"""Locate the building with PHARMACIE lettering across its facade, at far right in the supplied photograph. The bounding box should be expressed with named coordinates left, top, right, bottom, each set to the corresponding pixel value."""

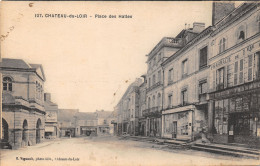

left=209, top=3, right=260, bottom=146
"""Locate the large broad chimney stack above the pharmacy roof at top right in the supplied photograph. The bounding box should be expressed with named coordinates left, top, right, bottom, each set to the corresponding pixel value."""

left=212, top=2, right=235, bottom=25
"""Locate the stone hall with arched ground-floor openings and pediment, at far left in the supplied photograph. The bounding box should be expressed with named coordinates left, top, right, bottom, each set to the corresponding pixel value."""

left=0, top=58, right=45, bottom=149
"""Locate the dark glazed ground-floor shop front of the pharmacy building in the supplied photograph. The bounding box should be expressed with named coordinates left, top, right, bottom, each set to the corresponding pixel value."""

left=210, top=80, right=260, bottom=145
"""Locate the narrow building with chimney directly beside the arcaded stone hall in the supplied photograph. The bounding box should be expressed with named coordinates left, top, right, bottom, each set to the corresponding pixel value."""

left=44, top=93, right=59, bottom=139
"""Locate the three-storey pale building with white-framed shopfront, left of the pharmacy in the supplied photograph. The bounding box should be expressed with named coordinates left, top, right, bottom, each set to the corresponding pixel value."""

left=162, top=23, right=212, bottom=140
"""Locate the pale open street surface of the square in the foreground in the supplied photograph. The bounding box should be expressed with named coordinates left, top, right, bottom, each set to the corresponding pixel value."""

left=1, top=136, right=259, bottom=166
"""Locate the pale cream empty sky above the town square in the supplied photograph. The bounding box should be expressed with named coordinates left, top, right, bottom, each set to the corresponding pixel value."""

left=1, top=1, right=220, bottom=112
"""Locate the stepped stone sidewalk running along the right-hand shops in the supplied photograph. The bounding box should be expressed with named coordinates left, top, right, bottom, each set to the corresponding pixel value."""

left=123, top=136, right=260, bottom=160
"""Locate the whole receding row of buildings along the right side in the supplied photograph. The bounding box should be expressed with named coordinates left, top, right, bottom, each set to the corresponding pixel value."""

left=115, top=2, right=260, bottom=147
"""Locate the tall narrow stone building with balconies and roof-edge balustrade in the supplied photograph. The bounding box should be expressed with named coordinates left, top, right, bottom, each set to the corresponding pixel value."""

left=142, top=37, right=184, bottom=137
